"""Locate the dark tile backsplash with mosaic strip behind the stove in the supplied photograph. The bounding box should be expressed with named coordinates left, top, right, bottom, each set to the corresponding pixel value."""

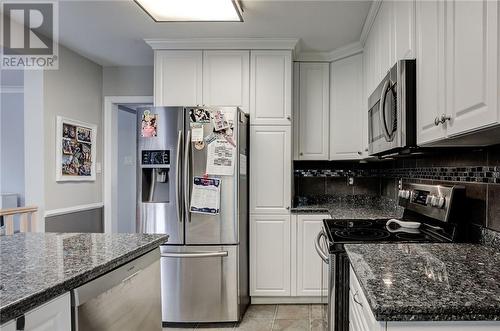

left=294, top=144, right=500, bottom=231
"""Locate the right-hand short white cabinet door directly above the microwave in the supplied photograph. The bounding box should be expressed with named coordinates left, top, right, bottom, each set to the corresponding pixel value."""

left=392, top=1, right=415, bottom=64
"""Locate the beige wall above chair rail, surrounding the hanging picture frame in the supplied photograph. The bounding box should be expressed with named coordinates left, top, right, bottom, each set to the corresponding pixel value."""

left=43, top=45, right=103, bottom=211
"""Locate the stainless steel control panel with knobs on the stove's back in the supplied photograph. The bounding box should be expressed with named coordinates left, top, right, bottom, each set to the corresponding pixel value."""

left=398, top=184, right=465, bottom=222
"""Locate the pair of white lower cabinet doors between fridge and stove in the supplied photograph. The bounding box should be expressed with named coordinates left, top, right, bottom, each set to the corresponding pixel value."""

left=250, top=214, right=330, bottom=303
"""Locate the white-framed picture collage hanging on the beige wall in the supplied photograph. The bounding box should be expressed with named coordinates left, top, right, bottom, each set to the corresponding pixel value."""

left=56, top=116, right=97, bottom=182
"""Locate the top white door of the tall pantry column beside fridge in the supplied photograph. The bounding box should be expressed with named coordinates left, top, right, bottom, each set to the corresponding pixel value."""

left=250, top=51, right=292, bottom=125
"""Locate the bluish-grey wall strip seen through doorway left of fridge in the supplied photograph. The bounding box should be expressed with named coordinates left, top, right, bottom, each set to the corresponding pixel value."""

left=116, top=106, right=137, bottom=233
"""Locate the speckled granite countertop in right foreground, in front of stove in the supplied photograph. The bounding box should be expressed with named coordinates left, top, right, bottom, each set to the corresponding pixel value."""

left=344, top=243, right=500, bottom=321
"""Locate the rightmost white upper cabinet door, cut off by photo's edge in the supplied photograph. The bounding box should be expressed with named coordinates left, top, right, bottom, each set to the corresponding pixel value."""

left=446, top=0, right=499, bottom=135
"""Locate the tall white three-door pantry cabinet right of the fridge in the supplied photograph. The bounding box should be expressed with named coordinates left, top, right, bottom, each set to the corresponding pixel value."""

left=250, top=50, right=292, bottom=296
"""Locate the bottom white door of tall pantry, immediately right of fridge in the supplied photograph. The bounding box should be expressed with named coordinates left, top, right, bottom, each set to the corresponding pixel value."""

left=250, top=215, right=291, bottom=296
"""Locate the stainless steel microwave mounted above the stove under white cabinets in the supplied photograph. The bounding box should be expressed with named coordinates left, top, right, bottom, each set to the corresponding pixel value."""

left=368, top=60, right=417, bottom=156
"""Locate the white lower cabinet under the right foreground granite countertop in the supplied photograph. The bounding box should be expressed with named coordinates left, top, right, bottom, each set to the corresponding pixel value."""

left=349, top=267, right=500, bottom=331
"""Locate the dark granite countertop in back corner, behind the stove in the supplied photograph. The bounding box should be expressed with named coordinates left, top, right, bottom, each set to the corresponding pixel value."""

left=291, top=195, right=403, bottom=219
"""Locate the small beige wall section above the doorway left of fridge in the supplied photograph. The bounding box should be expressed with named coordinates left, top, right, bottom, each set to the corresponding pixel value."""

left=103, top=66, right=153, bottom=96
